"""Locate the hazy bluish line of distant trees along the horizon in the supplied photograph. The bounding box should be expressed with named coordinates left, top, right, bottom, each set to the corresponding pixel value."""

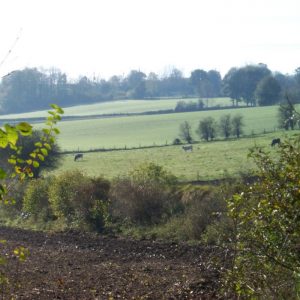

left=0, top=64, right=300, bottom=113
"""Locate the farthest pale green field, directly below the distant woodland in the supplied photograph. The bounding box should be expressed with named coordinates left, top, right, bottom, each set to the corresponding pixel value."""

left=0, top=98, right=232, bottom=120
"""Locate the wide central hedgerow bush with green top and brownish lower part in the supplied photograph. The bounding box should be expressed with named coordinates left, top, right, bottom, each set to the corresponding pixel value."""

left=110, top=163, right=181, bottom=225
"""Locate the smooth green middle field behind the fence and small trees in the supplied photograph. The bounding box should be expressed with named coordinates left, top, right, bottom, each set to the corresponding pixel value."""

left=37, top=106, right=278, bottom=151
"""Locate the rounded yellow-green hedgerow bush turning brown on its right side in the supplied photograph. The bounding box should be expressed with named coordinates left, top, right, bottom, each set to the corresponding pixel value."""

left=49, top=171, right=110, bottom=231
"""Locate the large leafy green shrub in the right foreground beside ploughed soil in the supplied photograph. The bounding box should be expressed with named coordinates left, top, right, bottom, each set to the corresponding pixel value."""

left=227, top=137, right=300, bottom=299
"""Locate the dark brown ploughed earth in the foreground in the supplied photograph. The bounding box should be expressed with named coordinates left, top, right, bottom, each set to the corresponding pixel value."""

left=0, top=227, right=223, bottom=299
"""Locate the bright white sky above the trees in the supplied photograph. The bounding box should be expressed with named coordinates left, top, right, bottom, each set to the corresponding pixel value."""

left=0, top=0, right=300, bottom=79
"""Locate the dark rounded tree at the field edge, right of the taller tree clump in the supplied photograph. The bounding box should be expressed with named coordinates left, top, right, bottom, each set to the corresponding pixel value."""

left=255, top=76, right=281, bottom=106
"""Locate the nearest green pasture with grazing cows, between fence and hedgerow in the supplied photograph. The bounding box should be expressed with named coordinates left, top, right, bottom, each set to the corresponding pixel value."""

left=49, top=132, right=299, bottom=181
